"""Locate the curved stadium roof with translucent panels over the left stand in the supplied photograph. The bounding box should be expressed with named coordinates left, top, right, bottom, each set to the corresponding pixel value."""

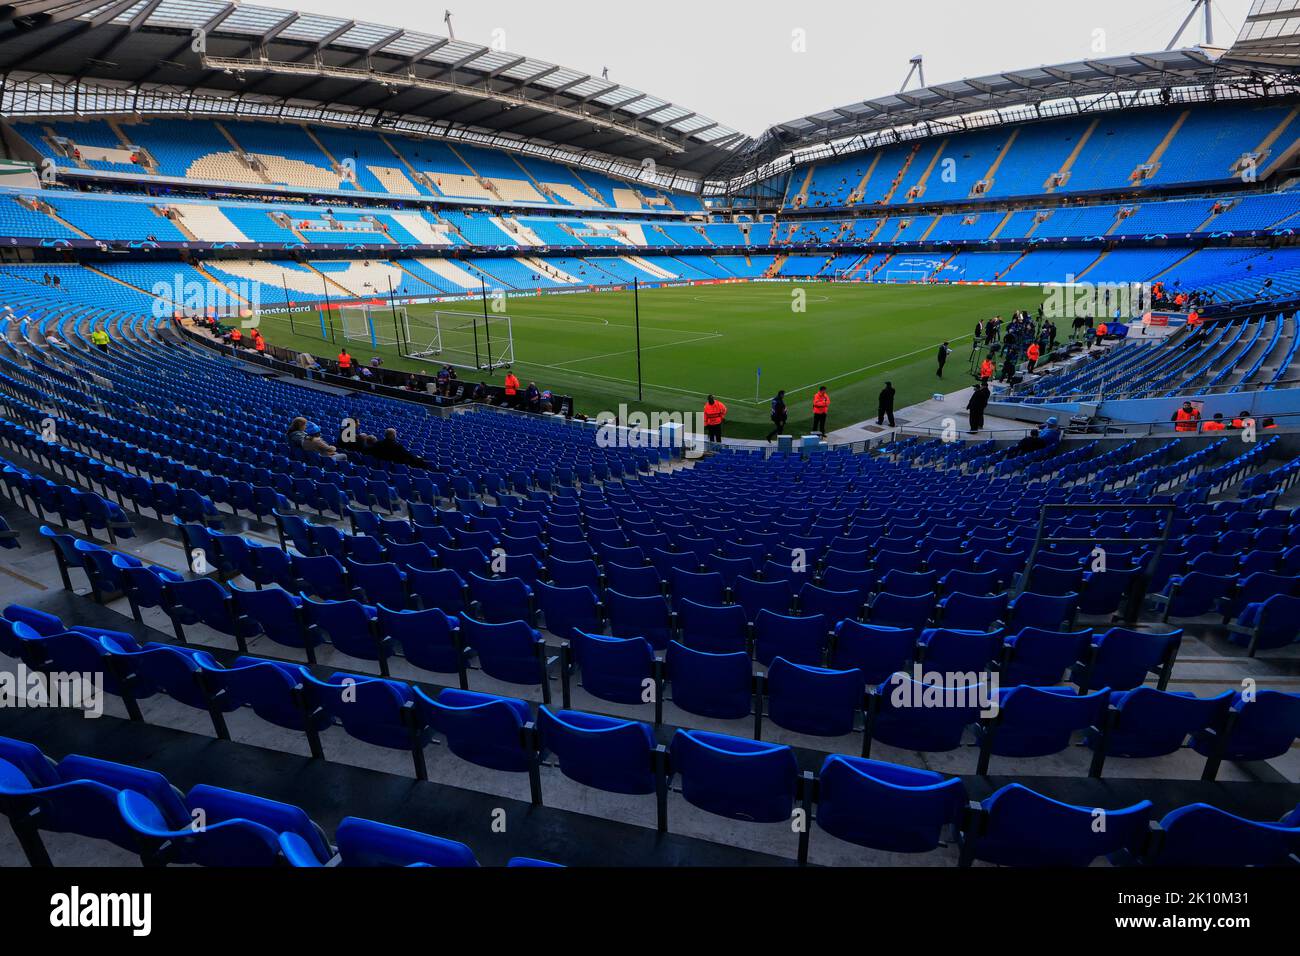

left=0, top=0, right=751, bottom=176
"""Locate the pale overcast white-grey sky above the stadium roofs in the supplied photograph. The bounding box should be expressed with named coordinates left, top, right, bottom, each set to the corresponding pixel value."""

left=287, top=0, right=1251, bottom=134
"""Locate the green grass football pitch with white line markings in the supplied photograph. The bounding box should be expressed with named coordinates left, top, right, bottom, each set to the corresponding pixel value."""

left=250, top=282, right=1045, bottom=438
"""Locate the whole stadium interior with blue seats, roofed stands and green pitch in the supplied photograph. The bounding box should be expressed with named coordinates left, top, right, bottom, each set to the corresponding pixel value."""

left=0, top=0, right=1300, bottom=920
